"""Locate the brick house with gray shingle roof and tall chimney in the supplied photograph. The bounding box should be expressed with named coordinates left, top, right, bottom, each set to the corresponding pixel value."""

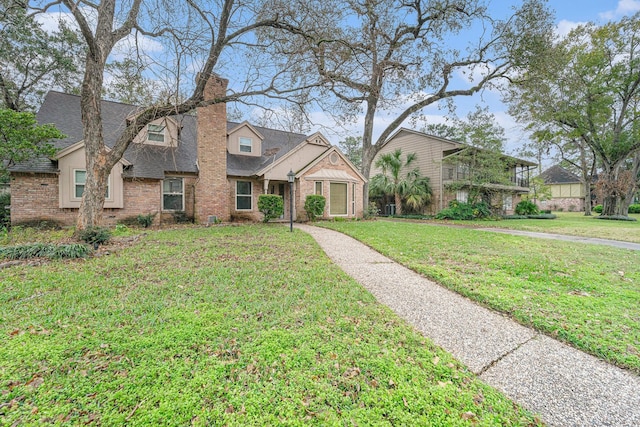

left=10, top=76, right=366, bottom=225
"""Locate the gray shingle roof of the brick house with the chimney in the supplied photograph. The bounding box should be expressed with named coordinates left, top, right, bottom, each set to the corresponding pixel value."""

left=11, top=91, right=307, bottom=179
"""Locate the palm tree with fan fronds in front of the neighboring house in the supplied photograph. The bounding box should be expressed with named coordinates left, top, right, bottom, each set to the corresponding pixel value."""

left=369, top=148, right=431, bottom=215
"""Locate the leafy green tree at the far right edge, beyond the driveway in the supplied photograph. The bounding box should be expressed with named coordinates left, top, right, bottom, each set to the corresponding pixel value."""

left=510, top=15, right=640, bottom=216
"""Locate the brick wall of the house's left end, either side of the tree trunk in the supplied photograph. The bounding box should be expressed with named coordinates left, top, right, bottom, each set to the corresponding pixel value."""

left=11, top=173, right=162, bottom=226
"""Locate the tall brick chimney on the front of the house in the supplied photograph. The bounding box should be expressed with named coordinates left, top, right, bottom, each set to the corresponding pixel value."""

left=195, top=74, right=230, bottom=223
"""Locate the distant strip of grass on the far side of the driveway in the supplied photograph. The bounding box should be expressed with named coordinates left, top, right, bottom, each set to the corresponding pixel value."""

left=424, top=212, right=640, bottom=243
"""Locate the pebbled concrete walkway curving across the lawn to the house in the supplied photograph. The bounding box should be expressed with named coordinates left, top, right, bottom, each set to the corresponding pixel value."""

left=296, top=224, right=640, bottom=427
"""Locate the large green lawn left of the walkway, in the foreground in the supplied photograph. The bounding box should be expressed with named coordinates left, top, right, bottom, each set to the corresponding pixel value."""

left=0, top=225, right=538, bottom=426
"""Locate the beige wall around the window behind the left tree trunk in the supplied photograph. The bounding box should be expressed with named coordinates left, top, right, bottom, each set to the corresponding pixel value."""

left=58, top=148, right=124, bottom=208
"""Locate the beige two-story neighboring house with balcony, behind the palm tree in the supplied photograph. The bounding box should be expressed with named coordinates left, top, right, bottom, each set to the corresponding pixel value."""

left=371, top=128, right=536, bottom=214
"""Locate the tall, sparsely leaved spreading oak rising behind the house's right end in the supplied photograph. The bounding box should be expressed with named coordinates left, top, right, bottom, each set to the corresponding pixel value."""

left=267, top=0, right=551, bottom=207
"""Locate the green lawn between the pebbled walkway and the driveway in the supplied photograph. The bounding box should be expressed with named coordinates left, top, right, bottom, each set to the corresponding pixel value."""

left=322, top=221, right=640, bottom=373
